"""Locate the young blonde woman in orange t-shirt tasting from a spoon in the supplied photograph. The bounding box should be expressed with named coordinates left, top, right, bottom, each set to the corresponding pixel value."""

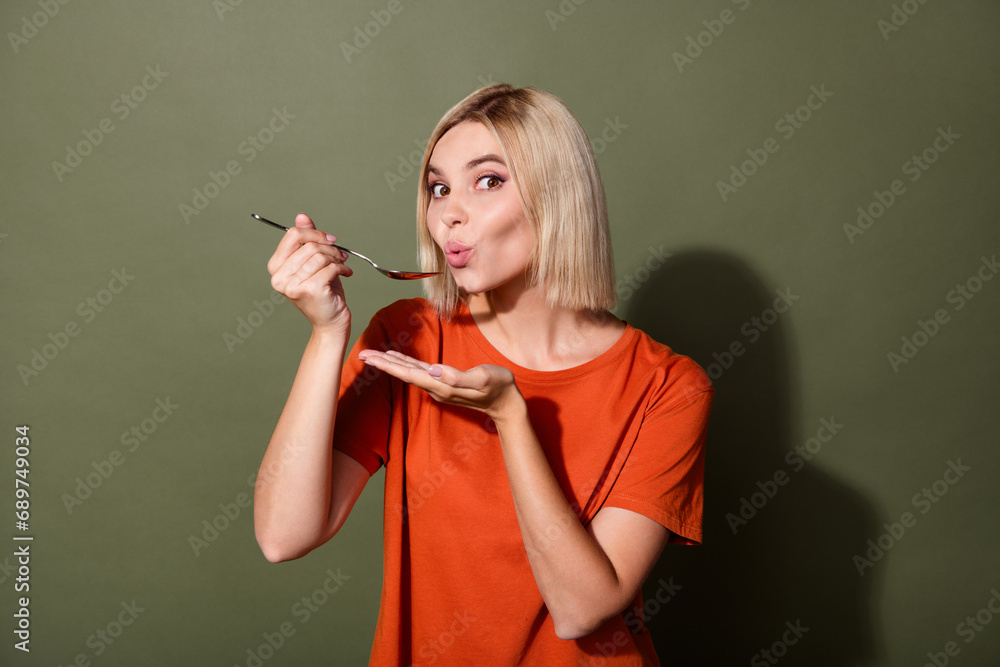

left=254, top=84, right=712, bottom=666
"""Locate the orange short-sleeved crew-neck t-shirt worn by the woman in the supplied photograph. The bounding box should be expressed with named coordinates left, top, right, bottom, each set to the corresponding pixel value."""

left=333, top=299, right=712, bottom=667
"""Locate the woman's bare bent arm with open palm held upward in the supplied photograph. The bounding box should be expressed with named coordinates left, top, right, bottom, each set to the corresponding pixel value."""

left=361, top=350, right=670, bottom=639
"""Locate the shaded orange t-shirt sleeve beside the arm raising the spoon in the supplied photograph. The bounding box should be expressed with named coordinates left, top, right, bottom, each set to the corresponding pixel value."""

left=333, top=304, right=408, bottom=475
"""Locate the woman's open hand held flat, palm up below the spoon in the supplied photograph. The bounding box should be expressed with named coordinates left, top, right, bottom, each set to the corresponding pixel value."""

left=358, top=350, right=524, bottom=420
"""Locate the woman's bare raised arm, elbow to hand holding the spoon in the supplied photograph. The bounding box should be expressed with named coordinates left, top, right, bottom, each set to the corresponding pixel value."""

left=254, top=214, right=369, bottom=562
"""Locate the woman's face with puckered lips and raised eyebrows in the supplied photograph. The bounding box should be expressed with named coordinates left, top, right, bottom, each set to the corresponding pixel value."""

left=426, top=121, right=535, bottom=294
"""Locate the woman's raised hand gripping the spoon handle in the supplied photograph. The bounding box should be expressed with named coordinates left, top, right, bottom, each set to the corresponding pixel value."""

left=267, top=213, right=354, bottom=335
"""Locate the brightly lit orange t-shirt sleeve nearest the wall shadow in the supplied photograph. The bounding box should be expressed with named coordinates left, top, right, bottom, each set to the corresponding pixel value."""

left=604, top=362, right=713, bottom=544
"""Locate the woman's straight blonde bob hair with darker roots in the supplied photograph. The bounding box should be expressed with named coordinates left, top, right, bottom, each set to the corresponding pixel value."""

left=417, top=84, right=615, bottom=317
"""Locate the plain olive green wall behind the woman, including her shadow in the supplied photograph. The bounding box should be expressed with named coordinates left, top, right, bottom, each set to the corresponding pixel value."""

left=0, top=0, right=1000, bottom=667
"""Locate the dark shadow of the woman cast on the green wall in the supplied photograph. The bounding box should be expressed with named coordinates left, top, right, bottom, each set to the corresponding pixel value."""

left=622, top=252, right=881, bottom=665
